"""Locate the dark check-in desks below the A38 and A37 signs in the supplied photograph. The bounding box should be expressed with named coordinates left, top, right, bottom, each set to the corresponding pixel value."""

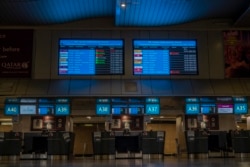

left=93, top=131, right=165, bottom=159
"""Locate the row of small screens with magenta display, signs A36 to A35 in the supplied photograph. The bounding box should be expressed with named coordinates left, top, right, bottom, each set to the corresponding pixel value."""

left=185, top=103, right=248, bottom=115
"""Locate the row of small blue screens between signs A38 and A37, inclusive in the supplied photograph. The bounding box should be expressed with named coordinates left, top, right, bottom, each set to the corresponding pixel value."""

left=96, top=104, right=160, bottom=116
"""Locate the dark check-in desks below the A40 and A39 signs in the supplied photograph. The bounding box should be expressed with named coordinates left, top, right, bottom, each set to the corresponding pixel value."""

left=0, top=132, right=74, bottom=159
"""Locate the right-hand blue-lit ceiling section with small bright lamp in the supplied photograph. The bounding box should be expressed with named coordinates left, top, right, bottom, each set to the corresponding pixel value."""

left=115, top=0, right=249, bottom=26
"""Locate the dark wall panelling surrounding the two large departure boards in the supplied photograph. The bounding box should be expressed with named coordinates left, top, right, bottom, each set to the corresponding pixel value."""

left=33, top=29, right=224, bottom=79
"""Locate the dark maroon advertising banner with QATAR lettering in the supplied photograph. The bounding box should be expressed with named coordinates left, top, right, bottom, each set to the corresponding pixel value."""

left=0, top=29, right=33, bottom=78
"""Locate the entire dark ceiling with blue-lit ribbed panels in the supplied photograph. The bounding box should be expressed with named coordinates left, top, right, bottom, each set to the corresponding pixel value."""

left=0, top=0, right=250, bottom=28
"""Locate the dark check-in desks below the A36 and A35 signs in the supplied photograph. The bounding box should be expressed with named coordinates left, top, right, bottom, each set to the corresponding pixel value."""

left=185, top=130, right=250, bottom=157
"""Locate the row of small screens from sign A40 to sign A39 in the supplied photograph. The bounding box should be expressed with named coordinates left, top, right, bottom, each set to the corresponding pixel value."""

left=4, top=104, right=70, bottom=116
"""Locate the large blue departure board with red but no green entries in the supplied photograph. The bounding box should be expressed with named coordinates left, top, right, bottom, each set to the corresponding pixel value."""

left=133, top=40, right=198, bottom=75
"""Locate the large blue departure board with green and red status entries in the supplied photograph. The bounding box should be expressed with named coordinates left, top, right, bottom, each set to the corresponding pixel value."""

left=58, top=39, right=124, bottom=75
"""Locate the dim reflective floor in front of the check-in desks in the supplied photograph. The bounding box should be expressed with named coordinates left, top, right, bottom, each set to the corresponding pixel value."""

left=0, top=156, right=250, bottom=167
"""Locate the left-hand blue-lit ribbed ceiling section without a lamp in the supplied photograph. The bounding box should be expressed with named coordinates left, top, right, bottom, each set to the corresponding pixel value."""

left=0, top=0, right=115, bottom=25
